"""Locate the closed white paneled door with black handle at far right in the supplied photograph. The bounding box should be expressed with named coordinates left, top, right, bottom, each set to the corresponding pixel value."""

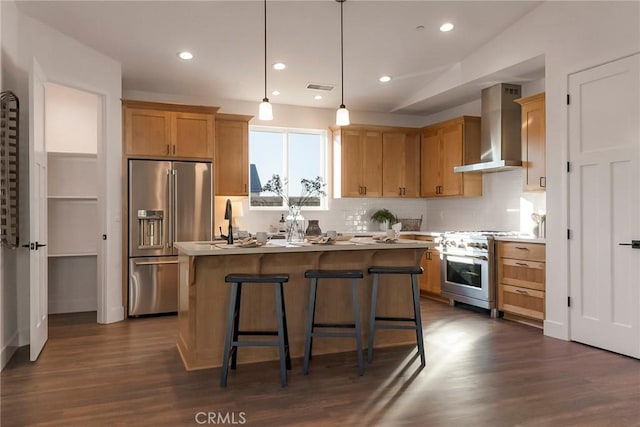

left=569, top=55, right=640, bottom=358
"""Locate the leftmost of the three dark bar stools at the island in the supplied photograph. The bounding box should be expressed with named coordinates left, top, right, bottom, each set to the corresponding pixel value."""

left=220, top=273, right=291, bottom=387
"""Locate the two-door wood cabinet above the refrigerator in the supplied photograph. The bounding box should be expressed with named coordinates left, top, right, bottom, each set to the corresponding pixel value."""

left=122, top=100, right=218, bottom=160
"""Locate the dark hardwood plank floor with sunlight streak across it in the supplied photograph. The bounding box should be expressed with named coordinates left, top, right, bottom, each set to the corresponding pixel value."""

left=1, top=300, right=640, bottom=427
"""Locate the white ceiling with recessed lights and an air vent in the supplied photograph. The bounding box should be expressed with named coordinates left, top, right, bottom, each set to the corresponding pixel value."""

left=18, top=0, right=544, bottom=115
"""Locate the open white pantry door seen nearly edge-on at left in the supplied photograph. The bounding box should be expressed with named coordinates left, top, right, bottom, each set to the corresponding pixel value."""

left=29, top=58, right=48, bottom=361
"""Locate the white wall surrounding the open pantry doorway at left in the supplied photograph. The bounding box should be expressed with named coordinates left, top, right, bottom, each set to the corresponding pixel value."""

left=0, top=1, right=124, bottom=370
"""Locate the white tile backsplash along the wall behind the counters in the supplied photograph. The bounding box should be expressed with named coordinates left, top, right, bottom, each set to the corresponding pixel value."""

left=214, top=169, right=546, bottom=234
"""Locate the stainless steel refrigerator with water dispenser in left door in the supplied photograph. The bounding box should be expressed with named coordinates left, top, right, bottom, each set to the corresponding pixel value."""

left=128, top=160, right=213, bottom=316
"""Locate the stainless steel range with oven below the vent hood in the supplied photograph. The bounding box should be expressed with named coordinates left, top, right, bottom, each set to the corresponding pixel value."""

left=440, top=231, right=518, bottom=317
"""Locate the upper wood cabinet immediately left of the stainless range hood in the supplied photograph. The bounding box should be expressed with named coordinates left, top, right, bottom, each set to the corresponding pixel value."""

left=420, top=116, right=482, bottom=197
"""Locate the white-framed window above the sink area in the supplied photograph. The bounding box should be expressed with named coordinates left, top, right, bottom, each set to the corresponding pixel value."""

left=249, top=126, right=328, bottom=209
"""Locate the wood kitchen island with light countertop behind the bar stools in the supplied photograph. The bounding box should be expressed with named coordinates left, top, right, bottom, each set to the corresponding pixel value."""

left=175, top=238, right=434, bottom=370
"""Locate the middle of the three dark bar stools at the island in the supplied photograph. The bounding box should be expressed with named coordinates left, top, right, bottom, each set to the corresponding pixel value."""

left=302, top=270, right=364, bottom=375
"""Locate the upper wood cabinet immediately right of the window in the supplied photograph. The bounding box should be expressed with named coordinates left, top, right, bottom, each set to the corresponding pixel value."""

left=332, top=126, right=382, bottom=197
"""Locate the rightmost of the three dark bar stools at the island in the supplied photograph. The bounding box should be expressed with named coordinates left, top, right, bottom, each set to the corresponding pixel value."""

left=367, top=266, right=426, bottom=367
